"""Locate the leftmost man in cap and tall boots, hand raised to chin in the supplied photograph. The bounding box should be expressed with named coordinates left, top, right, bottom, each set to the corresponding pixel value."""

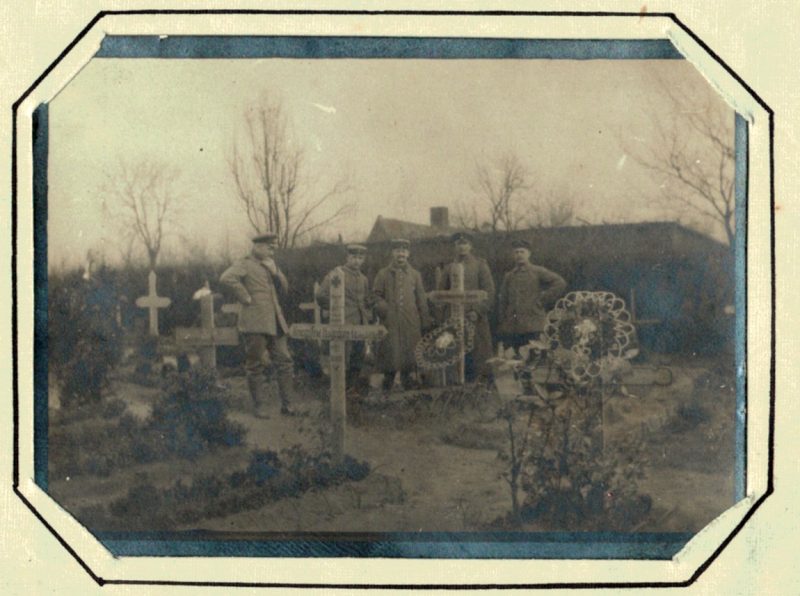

left=220, top=234, right=294, bottom=418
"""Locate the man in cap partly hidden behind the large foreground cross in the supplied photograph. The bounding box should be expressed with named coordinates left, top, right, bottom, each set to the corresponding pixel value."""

left=316, top=244, right=372, bottom=394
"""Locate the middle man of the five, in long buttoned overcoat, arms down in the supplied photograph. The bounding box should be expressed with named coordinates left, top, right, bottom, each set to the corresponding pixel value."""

left=372, top=240, right=430, bottom=391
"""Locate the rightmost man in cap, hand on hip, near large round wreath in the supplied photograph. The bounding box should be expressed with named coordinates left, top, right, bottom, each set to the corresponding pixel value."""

left=498, top=240, right=567, bottom=350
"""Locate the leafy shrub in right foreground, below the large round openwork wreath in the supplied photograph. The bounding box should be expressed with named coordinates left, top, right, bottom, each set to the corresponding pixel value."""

left=498, top=389, right=651, bottom=531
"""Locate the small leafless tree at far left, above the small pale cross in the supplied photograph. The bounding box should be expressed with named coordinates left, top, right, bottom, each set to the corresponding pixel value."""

left=101, top=159, right=183, bottom=270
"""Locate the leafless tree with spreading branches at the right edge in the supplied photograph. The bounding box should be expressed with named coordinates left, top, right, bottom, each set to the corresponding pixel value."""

left=621, top=78, right=736, bottom=245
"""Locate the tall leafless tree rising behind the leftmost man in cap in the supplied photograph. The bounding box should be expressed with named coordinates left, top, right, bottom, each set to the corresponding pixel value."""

left=228, top=98, right=352, bottom=248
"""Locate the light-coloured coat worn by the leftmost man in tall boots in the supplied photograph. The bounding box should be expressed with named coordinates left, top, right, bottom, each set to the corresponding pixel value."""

left=219, top=255, right=288, bottom=335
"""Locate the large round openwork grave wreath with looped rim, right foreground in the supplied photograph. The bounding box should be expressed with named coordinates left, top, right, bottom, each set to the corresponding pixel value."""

left=542, top=291, right=638, bottom=386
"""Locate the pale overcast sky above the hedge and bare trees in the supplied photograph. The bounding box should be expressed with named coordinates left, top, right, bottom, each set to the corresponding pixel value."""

left=43, top=59, right=733, bottom=266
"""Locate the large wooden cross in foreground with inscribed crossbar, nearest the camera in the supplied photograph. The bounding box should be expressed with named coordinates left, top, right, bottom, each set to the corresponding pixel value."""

left=289, top=267, right=386, bottom=462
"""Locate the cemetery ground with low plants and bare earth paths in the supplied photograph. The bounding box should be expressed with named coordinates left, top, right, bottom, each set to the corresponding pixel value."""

left=49, top=344, right=734, bottom=532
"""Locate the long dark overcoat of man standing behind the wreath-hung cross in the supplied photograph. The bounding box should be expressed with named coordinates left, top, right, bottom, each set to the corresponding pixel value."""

left=441, top=255, right=495, bottom=372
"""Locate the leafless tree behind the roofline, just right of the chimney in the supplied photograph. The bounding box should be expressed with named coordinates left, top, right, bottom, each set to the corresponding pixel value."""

left=456, top=153, right=532, bottom=232
